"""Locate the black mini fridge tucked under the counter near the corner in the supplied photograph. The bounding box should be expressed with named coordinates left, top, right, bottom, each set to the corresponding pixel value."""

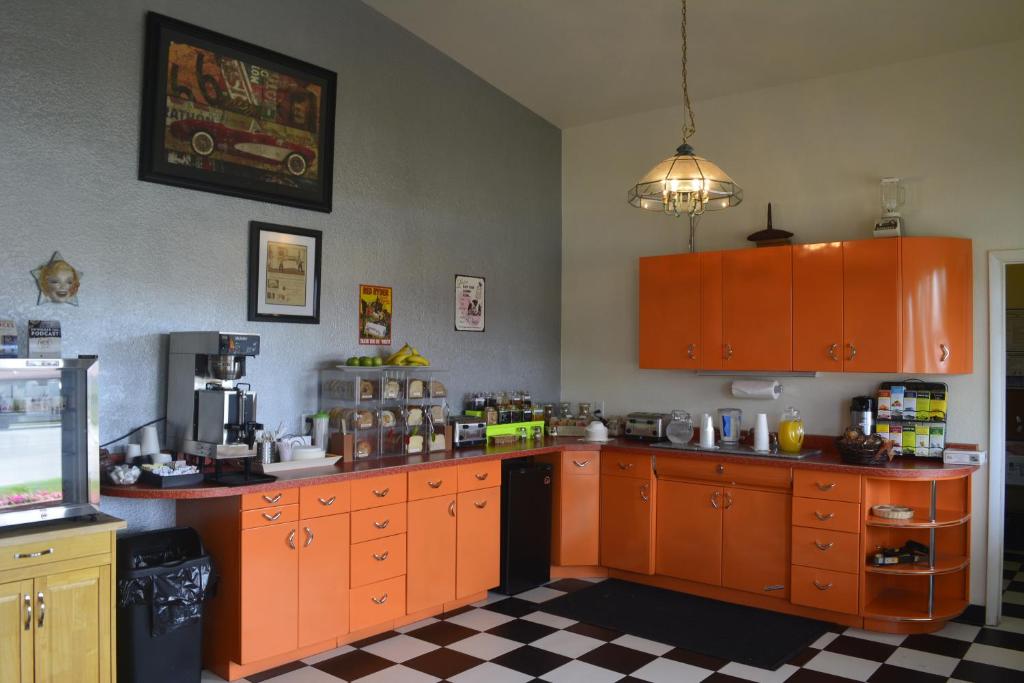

left=498, top=458, right=552, bottom=595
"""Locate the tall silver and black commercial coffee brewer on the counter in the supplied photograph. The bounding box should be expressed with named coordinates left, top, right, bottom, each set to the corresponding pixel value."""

left=167, top=332, right=274, bottom=485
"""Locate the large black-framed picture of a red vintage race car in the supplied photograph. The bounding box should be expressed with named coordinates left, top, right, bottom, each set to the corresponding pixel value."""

left=138, top=12, right=337, bottom=212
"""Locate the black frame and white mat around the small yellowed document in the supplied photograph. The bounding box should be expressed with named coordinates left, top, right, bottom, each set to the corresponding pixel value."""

left=249, top=220, right=324, bottom=325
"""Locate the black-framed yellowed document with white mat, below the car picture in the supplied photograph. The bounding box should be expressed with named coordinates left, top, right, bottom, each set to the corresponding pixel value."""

left=249, top=221, right=324, bottom=325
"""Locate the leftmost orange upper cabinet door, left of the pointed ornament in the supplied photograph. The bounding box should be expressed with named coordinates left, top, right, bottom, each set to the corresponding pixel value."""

left=638, top=254, right=700, bottom=370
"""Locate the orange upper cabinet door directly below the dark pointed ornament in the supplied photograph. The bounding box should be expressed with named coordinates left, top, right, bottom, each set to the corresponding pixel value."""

left=722, top=247, right=793, bottom=370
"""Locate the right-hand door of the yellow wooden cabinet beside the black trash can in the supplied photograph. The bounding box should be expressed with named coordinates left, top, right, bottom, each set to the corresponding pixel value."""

left=33, top=566, right=112, bottom=683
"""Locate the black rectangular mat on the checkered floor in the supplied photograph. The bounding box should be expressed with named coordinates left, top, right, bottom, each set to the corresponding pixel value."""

left=540, top=579, right=829, bottom=670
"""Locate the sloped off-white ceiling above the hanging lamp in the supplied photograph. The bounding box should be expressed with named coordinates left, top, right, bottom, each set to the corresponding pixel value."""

left=364, top=0, right=1024, bottom=128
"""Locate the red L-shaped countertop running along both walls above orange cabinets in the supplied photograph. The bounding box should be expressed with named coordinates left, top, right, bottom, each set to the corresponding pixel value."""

left=100, top=437, right=978, bottom=500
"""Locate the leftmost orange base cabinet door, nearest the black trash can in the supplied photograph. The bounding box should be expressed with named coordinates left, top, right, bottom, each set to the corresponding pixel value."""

left=239, top=522, right=301, bottom=664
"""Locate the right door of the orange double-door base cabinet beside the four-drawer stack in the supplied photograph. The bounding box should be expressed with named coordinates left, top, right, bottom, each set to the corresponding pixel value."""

left=722, top=488, right=791, bottom=598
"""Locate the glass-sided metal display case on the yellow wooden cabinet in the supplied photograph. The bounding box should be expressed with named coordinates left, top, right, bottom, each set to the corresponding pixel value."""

left=0, top=358, right=99, bottom=528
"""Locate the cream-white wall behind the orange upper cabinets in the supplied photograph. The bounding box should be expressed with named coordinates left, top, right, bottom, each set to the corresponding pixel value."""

left=561, top=41, right=1024, bottom=602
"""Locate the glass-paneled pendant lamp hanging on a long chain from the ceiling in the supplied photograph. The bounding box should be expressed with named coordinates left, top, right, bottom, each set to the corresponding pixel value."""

left=629, top=0, right=743, bottom=252
